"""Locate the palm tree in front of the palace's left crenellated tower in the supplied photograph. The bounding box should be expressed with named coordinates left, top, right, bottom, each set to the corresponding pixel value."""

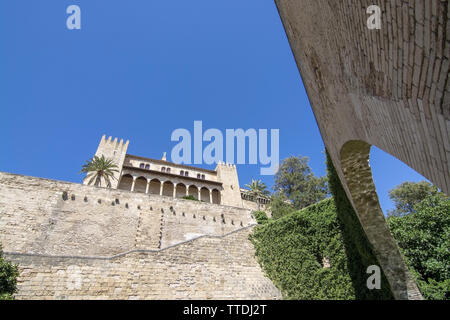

left=80, top=155, right=119, bottom=188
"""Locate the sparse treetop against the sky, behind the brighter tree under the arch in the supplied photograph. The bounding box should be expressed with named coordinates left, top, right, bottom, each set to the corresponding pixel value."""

left=388, top=181, right=443, bottom=216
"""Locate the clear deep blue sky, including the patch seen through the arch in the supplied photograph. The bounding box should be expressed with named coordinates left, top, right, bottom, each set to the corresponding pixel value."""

left=0, top=0, right=428, bottom=215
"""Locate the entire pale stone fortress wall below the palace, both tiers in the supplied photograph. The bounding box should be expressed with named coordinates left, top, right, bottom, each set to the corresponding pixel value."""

left=0, top=173, right=281, bottom=299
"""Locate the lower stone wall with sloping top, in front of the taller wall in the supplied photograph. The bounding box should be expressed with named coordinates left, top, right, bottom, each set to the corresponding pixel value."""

left=6, top=228, right=281, bottom=299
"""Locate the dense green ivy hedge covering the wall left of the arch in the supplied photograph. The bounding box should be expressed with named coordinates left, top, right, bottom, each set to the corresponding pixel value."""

left=250, top=152, right=393, bottom=300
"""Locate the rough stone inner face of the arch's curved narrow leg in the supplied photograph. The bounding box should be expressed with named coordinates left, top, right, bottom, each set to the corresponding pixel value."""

left=340, top=140, right=420, bottom=299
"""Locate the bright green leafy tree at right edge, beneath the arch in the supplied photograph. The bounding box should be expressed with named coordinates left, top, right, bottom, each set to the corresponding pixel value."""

left=387, top=194, right=450, bottom=300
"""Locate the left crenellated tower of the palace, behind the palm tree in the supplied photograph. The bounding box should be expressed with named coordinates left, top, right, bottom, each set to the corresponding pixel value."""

left=83, top=135, right=129, bottom=189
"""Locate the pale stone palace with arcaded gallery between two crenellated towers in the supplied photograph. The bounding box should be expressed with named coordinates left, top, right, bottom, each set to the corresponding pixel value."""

left=83, top=135, right=269, bottom=210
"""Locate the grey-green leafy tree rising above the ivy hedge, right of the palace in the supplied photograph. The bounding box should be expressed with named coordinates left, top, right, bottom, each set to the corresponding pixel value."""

left=273, top=156, right=328, bottom=209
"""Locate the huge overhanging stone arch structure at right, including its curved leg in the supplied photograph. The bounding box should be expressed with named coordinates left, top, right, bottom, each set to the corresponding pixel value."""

left=276, top=0, right=450, bottom=299
